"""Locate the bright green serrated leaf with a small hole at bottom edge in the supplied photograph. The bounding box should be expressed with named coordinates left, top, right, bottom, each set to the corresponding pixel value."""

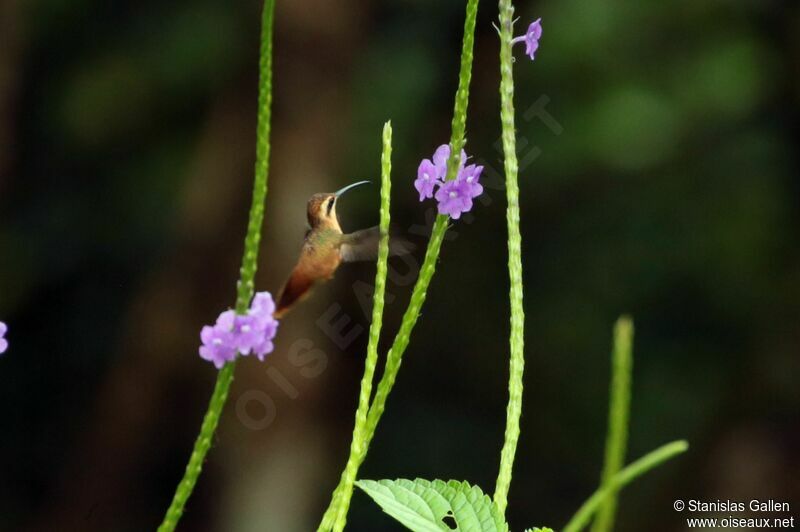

left=356, top=478, right=508, bottom=532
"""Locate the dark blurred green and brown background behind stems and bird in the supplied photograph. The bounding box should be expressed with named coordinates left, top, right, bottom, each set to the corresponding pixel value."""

left=0, top=0, right=800, bottom=532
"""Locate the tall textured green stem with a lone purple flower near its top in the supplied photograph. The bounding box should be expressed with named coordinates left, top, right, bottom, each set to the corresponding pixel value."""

left=494, top=0, right=525, bottom=514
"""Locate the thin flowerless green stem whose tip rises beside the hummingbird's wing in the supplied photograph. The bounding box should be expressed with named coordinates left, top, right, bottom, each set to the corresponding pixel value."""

left=334, top=122, right=392, bottom=531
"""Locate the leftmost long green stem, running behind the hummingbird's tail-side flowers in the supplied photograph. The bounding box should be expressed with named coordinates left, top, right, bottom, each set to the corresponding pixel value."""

left=158, top=0, right=275, bottom=532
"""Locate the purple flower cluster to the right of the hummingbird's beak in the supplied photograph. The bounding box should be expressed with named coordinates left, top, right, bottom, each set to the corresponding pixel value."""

left=414, top=144, right=483, bottom=220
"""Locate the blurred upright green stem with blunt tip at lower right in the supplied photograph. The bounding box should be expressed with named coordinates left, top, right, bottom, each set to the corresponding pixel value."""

left=592, top=316, right=633, bottom=532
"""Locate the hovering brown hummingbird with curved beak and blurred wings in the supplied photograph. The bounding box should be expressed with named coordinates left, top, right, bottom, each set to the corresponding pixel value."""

left=274, top=181, right=411, bottom=318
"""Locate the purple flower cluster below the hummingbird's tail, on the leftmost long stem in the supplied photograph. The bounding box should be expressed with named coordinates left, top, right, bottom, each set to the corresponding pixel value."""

left=200, top=292, right=278, bottom=368
